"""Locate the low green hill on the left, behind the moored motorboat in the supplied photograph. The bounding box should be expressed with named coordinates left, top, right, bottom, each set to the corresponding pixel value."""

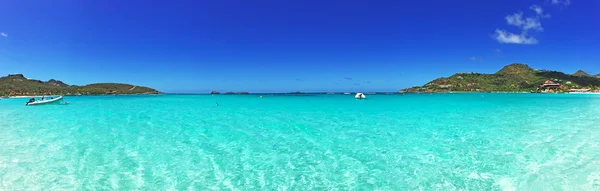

left=0, top=74, right=160, bottom=96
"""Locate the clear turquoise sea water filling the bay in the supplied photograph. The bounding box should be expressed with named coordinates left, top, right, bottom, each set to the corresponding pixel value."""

left=0, top=94, right=600, bottom=190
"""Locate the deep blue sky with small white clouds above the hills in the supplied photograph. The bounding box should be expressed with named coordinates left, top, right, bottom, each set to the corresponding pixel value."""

left=0, top=0, right=600, bottom=92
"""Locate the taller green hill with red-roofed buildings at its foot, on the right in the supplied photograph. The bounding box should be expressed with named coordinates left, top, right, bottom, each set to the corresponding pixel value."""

left=401, top=63, right=600, bottom=92
